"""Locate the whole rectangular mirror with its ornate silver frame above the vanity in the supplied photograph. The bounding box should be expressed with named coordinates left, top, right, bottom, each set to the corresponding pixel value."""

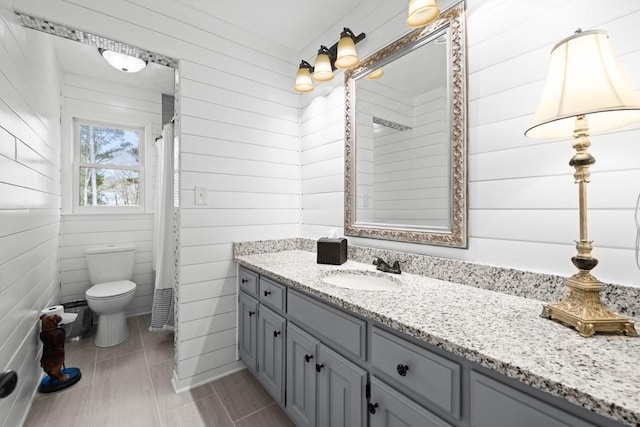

left=345, top=3, right=467, bottom=248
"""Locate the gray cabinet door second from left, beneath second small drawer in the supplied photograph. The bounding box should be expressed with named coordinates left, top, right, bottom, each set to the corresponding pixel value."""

left=258, top=306, right=285, bottom=405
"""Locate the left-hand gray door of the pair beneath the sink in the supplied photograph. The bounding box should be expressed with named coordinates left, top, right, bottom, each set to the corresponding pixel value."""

left=286, top=323, right=319, bottom=427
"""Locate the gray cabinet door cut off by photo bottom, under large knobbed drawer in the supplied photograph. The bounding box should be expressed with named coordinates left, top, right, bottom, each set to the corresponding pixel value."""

left=368, top=377, right=452, bottom=427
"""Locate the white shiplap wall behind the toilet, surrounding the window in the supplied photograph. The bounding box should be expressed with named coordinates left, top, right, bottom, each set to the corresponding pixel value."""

left=61, top=73, right=162, bottom=315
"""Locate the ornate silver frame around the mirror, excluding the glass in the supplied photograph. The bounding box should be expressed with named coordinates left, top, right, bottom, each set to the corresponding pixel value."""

left=344, top=3, right=467, bottom=248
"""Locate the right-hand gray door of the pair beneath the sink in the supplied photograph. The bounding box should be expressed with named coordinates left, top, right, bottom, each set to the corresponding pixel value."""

left=316, top=344, right=367, bottom=427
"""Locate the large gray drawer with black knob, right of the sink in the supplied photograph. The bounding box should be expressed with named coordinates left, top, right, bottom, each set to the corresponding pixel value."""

left=371, top=327, right=462, bottom=418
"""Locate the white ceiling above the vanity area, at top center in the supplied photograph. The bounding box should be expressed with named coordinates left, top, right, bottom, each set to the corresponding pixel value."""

left=175, top=0, right=364, bottom=52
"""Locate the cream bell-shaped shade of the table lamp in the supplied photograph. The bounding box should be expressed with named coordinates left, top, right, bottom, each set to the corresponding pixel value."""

left=525, top=30, right=640, bottom=138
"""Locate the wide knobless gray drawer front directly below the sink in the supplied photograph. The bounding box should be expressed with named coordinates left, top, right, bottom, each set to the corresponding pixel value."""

left=287, top=290, right=367, bottom=360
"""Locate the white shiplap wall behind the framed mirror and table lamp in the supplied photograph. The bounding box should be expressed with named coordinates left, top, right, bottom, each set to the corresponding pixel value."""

left=301, top=0, right=640, bottom=286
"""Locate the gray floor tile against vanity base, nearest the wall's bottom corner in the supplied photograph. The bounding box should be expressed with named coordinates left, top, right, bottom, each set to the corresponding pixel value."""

left=212, top=369, right=273, bottom=421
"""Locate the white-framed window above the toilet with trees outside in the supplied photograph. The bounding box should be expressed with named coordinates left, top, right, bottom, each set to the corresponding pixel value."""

left=74, top=119, right=144, bottom=210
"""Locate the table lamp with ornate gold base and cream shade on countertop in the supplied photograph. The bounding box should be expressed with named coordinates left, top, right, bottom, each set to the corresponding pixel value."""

left=525, top=30, right=640, bottom=337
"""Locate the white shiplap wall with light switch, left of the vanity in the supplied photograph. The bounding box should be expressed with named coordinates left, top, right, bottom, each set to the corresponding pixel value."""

left=16, top=0, right=300, bottom=388
